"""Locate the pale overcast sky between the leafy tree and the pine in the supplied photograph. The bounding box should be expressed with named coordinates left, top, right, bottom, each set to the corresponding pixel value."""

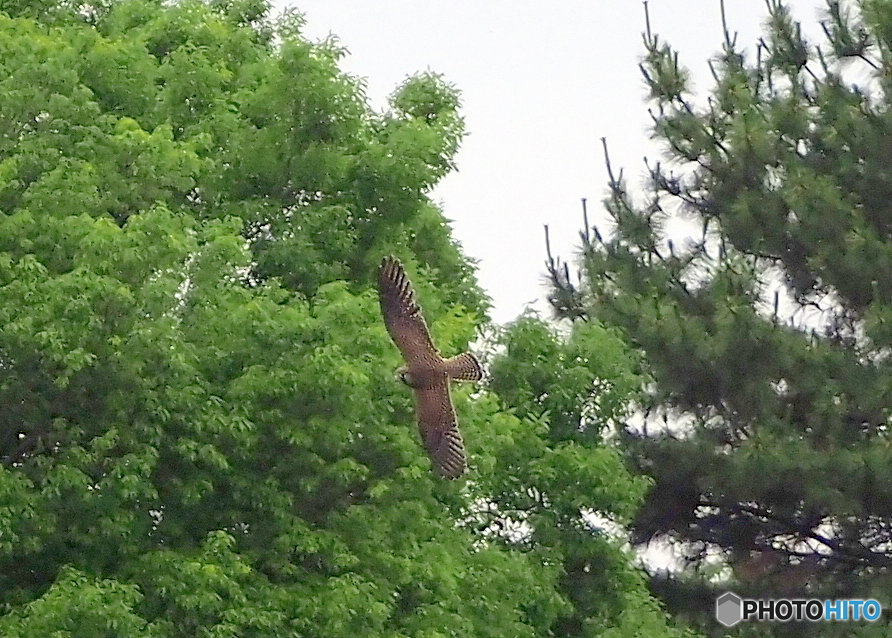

left=276, top=0, right=824, bottom=322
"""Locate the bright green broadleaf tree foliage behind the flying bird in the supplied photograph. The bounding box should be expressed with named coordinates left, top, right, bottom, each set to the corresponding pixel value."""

left=0, top=0, right=692, bottom=638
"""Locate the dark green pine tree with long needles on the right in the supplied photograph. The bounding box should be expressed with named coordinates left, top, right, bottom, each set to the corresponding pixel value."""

left=551, top=0, right=892, bottom=635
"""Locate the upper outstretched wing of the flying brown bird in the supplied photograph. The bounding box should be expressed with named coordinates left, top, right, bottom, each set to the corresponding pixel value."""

left=378, top=257, right=440, bottom=366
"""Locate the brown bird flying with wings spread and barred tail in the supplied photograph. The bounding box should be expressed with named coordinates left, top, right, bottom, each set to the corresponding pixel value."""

left=378, top=257, right=483, bottom=479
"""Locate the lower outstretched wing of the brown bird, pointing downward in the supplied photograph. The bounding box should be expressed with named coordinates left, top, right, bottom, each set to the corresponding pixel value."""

left=415, top=383, right=466, bottom=479
